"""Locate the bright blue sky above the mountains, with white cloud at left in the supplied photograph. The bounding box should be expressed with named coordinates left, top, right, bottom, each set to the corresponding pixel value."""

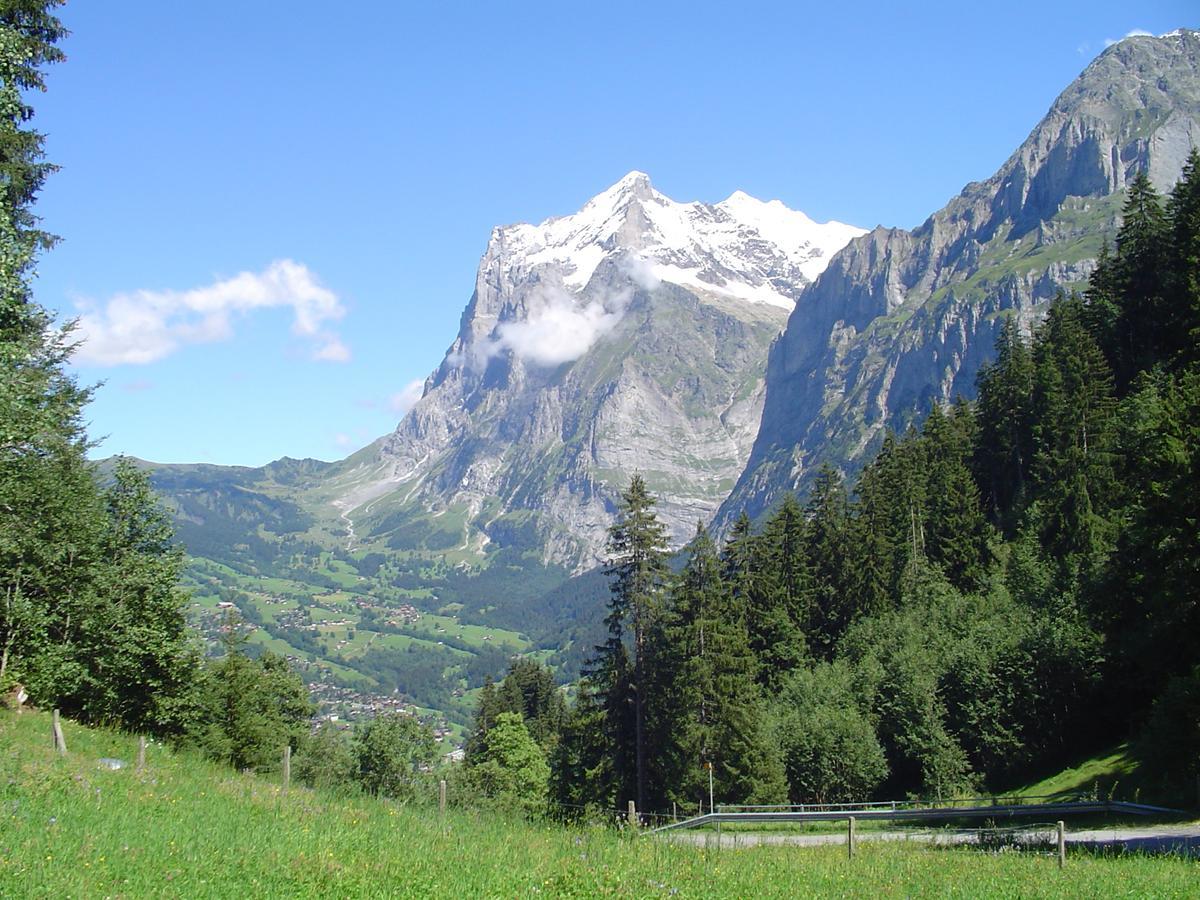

left=34, top=0, right=1200, bottom=464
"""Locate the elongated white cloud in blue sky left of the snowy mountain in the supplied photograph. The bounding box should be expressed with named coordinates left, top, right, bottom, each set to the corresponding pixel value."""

left=74, top=259, right=350, bottom=366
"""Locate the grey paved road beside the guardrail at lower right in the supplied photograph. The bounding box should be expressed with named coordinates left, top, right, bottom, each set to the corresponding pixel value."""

left=661, top=822, right=1200, bottom=857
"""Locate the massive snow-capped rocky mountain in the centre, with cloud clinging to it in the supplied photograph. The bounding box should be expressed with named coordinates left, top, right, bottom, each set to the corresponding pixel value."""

left=335, top=173, right=862, bottom=568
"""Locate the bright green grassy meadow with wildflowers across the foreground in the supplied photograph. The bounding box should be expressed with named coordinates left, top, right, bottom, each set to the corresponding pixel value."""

left=0, top=712, right=1200, bottom=898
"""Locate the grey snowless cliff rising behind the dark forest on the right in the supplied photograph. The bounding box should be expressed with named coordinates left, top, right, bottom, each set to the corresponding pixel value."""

left=719, top=31, right=1200, bottom=526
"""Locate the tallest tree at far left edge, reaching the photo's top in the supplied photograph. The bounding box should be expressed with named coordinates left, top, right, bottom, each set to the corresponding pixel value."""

left=0, top=2, right=85, bottom=702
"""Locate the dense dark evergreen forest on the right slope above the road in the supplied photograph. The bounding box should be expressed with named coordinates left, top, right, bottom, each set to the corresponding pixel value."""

left=476, top=160, right=1200, bottom=811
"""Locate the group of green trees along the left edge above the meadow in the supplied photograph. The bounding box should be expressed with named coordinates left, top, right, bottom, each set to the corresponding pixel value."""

left=0, top=0, right=369, bottom=787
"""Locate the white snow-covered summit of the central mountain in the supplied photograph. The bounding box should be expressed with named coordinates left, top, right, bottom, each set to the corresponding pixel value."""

left=487, top=172, right=864, bottom=310
